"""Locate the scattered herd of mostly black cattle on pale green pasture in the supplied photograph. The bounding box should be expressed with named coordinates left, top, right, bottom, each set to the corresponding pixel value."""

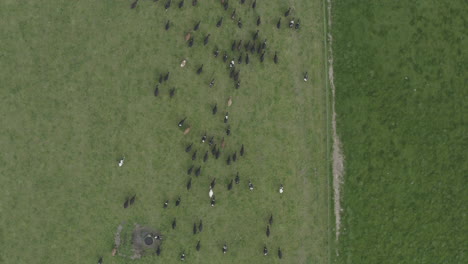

left=98, top=0, right=309, bottom=264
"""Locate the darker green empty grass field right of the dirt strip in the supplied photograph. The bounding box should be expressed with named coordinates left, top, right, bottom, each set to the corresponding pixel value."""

left=333, top=0, right=468, bottom=264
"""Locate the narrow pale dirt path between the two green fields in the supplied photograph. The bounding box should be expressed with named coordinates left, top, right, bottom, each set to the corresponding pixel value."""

left=327, top=0, right=344, bottom=240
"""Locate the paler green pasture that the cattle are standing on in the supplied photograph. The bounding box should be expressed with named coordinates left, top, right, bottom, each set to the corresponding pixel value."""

left=0, top=0, right=330, bottom=264
